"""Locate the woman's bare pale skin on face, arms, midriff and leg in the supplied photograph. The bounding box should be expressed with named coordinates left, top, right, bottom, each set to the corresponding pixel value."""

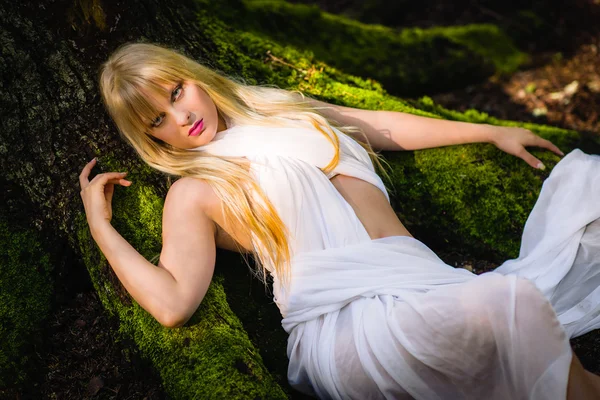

left=79, top=82, right=600, bottom=400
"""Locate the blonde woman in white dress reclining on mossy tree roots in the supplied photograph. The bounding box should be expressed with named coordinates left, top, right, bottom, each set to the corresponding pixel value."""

left=80, top=44, right=600, bottom=399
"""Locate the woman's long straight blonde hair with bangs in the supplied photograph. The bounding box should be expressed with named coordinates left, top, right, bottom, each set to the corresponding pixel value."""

left=100, top=43, right=381, bottom=285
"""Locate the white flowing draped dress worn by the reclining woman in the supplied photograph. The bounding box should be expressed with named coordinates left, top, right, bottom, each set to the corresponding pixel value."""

left=195, top=125, right=600, bottom=400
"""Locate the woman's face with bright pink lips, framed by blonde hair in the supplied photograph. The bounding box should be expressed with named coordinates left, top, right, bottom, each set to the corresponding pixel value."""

left=148, top=81, right=227, bottom=149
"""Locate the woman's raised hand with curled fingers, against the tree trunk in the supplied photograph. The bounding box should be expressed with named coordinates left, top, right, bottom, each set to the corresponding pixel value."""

left=79, top=158, right=131, bottom=229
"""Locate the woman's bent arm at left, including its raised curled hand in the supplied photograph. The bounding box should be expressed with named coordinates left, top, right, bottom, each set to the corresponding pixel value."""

left=80, top=160, right=215, bottom=327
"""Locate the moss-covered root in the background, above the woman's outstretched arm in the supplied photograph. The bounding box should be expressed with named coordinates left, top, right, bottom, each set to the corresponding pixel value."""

left=201, top=0, right=527, bottom=96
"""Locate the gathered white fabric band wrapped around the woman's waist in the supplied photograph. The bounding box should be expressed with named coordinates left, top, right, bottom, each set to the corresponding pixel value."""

left=273, top=236, right=475, bottom=324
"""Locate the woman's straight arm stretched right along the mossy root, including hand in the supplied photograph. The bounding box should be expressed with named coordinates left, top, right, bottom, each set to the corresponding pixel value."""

left=311, top=100, right=563, bottom=169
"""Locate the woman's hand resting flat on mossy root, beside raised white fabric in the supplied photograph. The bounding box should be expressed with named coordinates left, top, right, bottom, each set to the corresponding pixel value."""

left=490, top=125, right=564, bottom=170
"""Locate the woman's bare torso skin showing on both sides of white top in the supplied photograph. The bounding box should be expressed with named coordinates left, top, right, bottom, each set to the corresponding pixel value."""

left=211, top=175, right=412, bottom=252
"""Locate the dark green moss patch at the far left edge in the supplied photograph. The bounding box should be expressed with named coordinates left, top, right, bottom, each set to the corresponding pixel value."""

left=0, top=218, right=53, bottom=388
